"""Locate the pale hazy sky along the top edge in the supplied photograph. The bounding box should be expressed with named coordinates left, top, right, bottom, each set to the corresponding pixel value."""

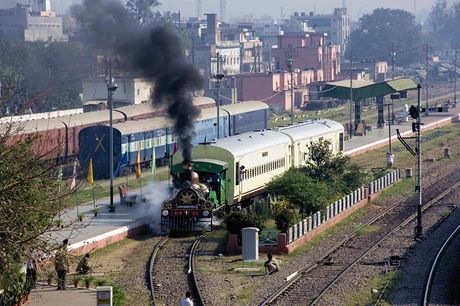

left=0, top=0, right=455, bottom=21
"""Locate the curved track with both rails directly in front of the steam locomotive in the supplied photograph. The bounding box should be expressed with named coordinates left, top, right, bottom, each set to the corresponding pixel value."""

left=149, top=235, right=204, bottom=305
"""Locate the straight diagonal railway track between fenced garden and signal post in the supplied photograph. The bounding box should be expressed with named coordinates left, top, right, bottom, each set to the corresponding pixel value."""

left=259, top=169, right=460, bottom=305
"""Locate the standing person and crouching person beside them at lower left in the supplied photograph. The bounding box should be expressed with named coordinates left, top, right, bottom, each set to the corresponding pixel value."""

left=54, top=239, right=91, bottom=290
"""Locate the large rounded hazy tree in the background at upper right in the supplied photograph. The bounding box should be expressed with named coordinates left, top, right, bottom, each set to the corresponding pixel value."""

left=347, top=8, right=424, bottom=64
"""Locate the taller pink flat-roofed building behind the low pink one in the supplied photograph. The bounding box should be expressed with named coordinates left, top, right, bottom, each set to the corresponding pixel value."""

left=272, top=33, right=340, bottom=81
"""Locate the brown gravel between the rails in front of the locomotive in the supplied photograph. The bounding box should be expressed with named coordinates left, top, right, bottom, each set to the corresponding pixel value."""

left=153, top=237, right=196, bottom=306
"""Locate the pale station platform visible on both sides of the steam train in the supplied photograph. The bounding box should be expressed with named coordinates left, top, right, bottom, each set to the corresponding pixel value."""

left=51, top=103, right=460, bottom=254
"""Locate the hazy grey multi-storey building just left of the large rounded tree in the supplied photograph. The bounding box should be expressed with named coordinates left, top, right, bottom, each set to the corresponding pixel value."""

left=285, top=7, right=350, bottom=56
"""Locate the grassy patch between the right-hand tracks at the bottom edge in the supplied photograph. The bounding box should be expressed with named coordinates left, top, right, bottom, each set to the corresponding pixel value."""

left=345, top=271, right=401, bottom=306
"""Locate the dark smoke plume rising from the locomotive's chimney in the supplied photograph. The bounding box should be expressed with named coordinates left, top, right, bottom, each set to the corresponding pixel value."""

left=72, top=0, right=202, bottom=161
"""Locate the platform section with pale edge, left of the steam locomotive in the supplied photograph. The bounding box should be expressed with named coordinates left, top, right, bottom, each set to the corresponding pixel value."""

left=54, top=181, right=169, bottom=255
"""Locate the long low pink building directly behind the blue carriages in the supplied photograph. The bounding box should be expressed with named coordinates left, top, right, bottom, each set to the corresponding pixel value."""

left=235, top=70, right=323, bottom=111
